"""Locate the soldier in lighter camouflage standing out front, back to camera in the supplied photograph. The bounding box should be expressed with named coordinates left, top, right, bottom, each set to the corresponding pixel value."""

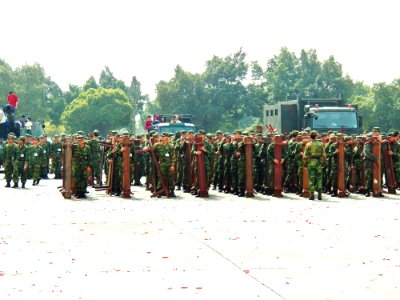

left=303, top=130, right=326, bottom=200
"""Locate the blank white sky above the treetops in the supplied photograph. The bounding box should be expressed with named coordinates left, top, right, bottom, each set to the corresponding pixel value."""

left=0, top=0, right=400, bottom=97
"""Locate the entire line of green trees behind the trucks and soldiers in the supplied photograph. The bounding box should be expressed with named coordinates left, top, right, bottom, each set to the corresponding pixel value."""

left=0, top=48, right=400, bottom=133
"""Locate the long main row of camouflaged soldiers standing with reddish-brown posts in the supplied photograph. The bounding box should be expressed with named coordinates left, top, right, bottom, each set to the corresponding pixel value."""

left=57, top=128, right=400, bottom=198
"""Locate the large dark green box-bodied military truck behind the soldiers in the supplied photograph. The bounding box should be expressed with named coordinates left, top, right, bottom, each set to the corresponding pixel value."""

left=263, top=98, right=362, bottom=134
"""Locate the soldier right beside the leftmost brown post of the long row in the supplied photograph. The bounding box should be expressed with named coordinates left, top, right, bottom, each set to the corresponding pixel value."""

left=72, top=135, right=91, bottom=198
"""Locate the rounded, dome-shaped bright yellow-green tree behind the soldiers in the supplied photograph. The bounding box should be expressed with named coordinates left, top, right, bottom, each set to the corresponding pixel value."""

left=61, top=88, right=133, bottom=133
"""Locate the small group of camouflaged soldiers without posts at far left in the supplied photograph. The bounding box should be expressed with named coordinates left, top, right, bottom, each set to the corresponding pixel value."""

left=2, top=133, right=62, bottom=188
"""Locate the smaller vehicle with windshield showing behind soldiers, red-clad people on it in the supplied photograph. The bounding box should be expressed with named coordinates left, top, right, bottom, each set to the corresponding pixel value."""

left=147, top=114, right=196, bottom=134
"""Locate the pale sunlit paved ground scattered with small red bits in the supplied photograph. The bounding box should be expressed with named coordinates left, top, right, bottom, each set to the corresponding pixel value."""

left=0, top=180, right=400, bottom=299
